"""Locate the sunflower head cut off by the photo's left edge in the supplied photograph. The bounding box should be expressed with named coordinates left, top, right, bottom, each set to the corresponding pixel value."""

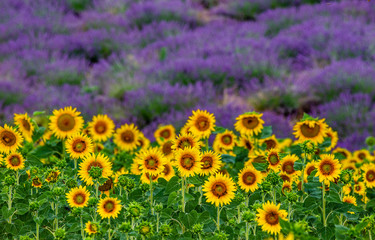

left=0, top=124, right=23, bottom=153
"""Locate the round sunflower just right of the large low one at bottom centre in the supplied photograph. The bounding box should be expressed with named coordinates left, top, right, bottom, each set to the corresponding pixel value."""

left=238, top=167, right=262, bottom=192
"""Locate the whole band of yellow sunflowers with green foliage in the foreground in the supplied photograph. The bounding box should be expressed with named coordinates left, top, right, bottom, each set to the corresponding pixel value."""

left=0, top=107, right=375, bottom=239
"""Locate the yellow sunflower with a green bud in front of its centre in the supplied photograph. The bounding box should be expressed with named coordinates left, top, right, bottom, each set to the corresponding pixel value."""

left=78, top=153, right=112, bottom=185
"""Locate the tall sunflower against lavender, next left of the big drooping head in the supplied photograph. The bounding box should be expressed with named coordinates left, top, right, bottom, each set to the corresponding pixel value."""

left=234, top=112, right=264, bottom=136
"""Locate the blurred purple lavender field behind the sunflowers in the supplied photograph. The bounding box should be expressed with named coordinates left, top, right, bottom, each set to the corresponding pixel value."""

left=0, top=0, right=375, bottom=148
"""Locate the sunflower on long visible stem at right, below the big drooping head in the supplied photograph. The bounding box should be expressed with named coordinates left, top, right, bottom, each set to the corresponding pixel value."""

left=315, top=154, right=341, bottom=185
